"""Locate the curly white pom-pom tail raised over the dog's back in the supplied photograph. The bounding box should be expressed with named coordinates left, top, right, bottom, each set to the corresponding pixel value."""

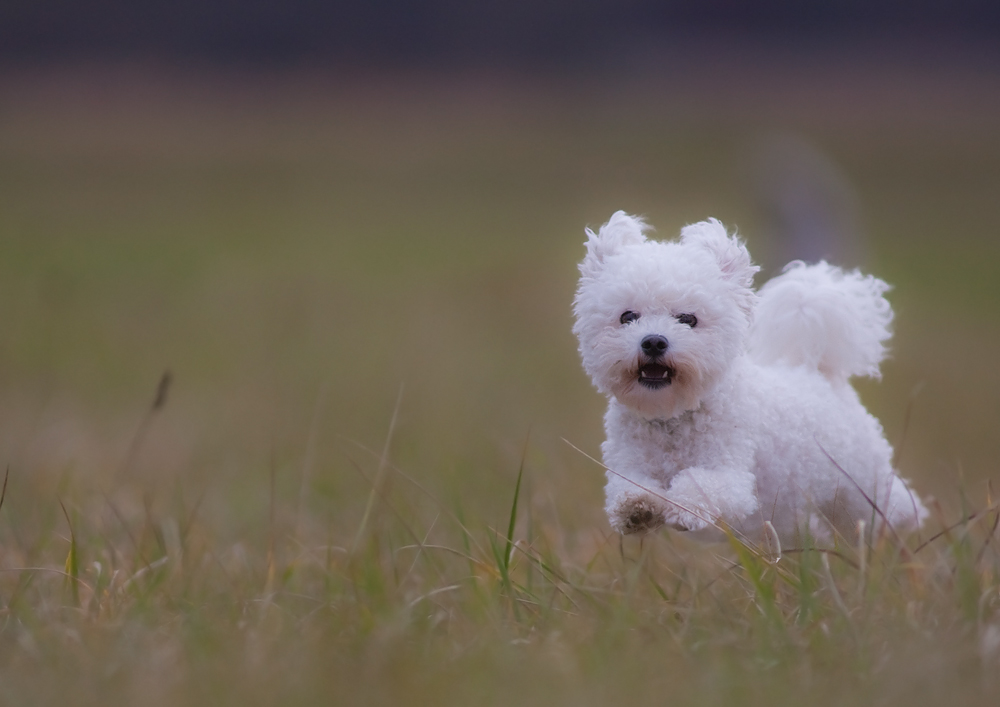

left=749, top=261, right=892, bottom=383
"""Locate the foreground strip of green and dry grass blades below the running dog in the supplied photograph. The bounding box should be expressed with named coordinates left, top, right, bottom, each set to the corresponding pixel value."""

left=0, top=426, right=1000, bottom=704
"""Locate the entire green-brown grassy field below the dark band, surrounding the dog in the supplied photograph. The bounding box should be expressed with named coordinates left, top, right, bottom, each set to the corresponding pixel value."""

left=0, top=68, right=1000, bottom=705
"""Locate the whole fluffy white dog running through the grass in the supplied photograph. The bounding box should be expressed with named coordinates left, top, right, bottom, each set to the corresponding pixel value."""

left=573, top=211, right=927, bottom=545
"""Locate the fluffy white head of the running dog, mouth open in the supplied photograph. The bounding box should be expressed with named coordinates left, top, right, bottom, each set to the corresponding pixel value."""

left=573, top=211, right=758, bottom=419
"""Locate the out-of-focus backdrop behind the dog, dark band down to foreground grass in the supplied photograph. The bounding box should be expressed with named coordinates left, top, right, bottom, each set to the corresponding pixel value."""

left=0, top=0, right=1000, bottom=537
